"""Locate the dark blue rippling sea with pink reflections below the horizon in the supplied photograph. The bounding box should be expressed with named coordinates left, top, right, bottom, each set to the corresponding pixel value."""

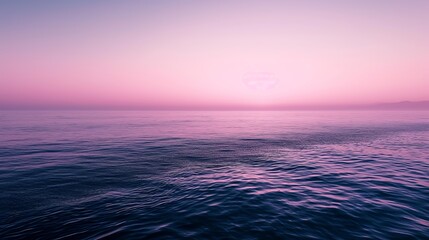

left=0, top=111, right=429, bottom=239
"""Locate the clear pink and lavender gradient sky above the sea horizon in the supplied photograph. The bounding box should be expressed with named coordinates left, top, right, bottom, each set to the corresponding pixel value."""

left=0, top=0, right=429, bottom=109
